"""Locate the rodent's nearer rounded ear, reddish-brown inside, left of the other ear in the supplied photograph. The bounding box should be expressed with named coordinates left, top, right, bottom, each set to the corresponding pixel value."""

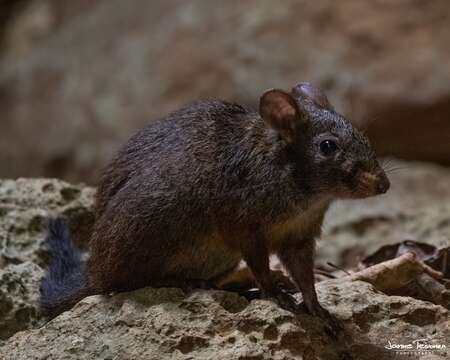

left=259, top=89, right=306, bottom=143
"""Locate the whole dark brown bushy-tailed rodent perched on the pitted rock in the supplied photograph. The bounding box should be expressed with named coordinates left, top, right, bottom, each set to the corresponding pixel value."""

left=40, top=83, right=389, bottom=329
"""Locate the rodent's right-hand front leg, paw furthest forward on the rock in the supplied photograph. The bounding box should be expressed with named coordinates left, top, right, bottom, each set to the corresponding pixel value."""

left=278, top=238, right=342, bottom=333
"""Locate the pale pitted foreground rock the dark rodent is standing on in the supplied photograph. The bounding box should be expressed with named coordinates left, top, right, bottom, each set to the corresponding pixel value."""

left=0, top=282, right=450, bottom=360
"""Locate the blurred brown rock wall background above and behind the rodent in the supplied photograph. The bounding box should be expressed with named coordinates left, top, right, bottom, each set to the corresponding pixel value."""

left=0, top=0, right=450, bottom=183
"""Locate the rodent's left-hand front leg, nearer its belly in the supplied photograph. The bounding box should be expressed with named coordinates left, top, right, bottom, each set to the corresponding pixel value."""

left=241, top=233, right=298, bottom=313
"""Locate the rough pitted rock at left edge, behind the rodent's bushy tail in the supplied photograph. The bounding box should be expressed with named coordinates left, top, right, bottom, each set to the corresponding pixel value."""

left=0, top=179, right=94, bottom=342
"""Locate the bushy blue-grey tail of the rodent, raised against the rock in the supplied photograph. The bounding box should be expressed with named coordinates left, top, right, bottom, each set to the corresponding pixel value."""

left=40, top=219, right=88, bottom=317
